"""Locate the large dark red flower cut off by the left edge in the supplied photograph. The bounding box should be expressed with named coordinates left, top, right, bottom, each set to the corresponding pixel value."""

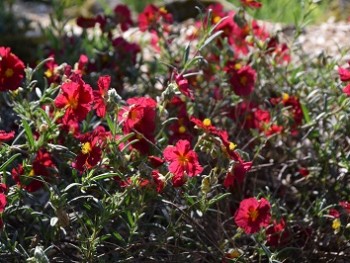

left=0, top=47, right=24, bottom=91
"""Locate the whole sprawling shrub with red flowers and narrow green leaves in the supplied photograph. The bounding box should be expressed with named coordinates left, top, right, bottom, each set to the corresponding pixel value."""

left=0, top=0, right=350, bottom=262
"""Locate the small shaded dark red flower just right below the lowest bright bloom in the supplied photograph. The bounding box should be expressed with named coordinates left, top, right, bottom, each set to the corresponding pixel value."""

left=266, top=218, right=289, bottom=247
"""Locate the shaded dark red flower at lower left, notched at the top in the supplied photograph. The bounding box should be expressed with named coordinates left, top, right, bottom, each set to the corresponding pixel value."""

left=11, top=149, right=56, bottom=192
